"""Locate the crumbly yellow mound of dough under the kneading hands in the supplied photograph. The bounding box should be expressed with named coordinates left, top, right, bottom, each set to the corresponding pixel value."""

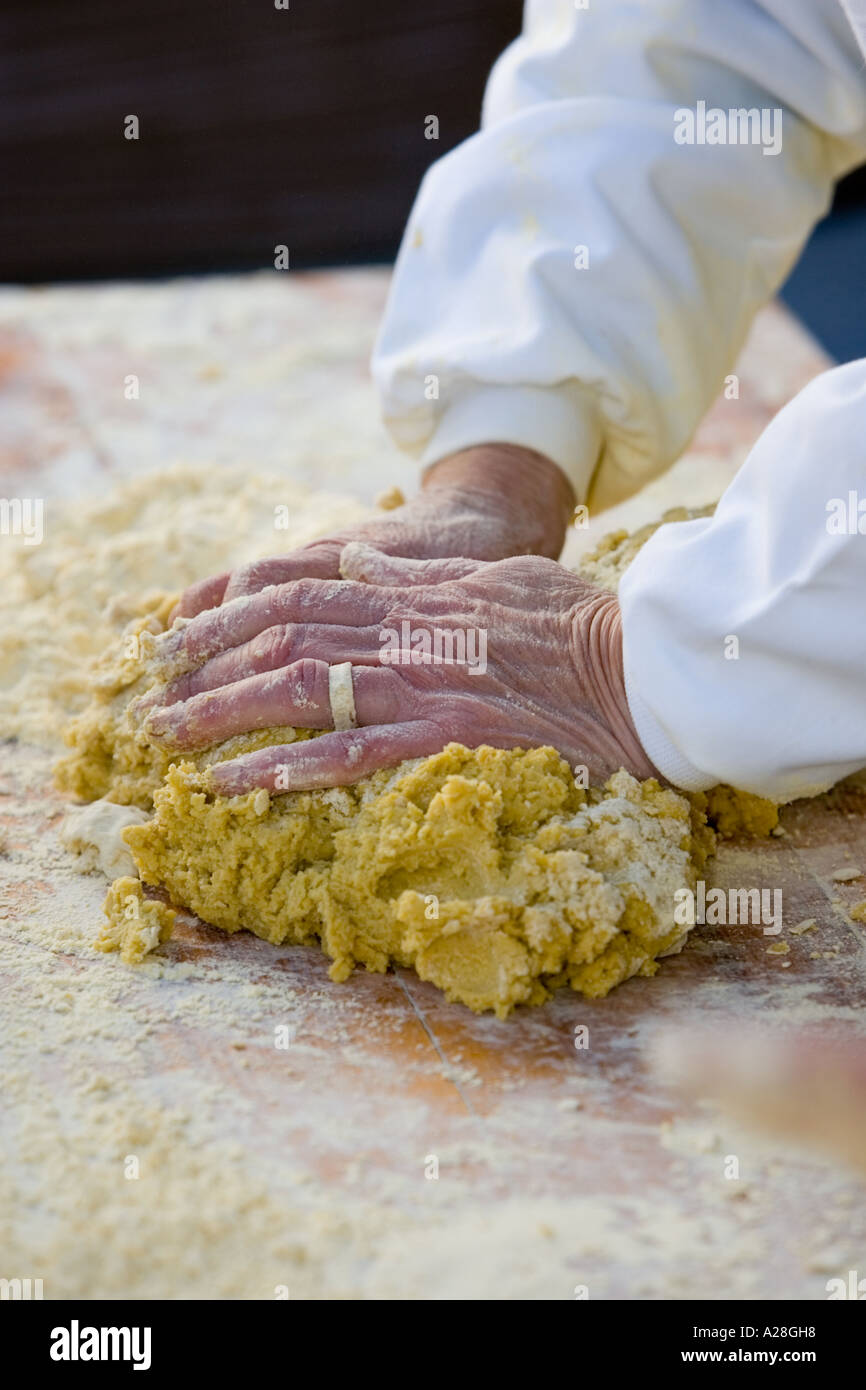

left=124, top=744, right=708, bottom=1017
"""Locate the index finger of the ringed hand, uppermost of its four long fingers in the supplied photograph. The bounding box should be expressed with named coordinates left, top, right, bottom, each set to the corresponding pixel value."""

left=158, top=580, right=395, bottom=669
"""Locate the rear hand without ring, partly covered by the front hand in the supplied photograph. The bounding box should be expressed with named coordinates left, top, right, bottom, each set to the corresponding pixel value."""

left=171, top=445, right=574, bottom=619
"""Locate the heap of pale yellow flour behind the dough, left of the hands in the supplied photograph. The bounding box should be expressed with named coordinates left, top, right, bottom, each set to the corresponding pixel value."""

left=0, top=464, right=368, bottom=746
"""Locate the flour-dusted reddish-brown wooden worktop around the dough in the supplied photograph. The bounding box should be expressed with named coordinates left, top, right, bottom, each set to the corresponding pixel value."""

left=0, top=270, right=866, bottom=1300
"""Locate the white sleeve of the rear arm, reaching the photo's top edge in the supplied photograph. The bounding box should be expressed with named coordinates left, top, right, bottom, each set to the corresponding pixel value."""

left=373, top=0, right=866, bottom=507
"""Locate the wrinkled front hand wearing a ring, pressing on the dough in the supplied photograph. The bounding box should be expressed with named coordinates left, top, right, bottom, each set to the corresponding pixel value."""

left=146, top=543, right=656, bottom=795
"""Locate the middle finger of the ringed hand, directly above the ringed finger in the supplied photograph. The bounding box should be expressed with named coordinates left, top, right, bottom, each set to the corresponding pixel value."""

left=151, top=623, right=382, bottom=709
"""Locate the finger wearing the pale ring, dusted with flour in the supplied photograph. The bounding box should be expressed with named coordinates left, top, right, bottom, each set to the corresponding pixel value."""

left=145, top=659, right=420, bottom=751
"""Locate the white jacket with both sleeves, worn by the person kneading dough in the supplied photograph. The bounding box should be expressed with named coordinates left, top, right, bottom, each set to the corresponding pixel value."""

left=373, top=0, right=866, bottom=801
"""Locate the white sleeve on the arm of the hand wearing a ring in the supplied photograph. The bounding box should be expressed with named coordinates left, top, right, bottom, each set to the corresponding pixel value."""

left=620, top=359, right=866, bottom=801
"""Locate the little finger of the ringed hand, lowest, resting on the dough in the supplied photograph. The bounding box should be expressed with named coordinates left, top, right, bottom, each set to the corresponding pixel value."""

left=210, top=719, right=450, bottom=796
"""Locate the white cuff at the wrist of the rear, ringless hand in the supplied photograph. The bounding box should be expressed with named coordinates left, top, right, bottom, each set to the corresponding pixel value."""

left=421, top=385, right=602, bottom=502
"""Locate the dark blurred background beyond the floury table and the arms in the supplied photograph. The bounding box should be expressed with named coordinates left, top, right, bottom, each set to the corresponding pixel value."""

left=0, top=0, right=866, bottom=359
